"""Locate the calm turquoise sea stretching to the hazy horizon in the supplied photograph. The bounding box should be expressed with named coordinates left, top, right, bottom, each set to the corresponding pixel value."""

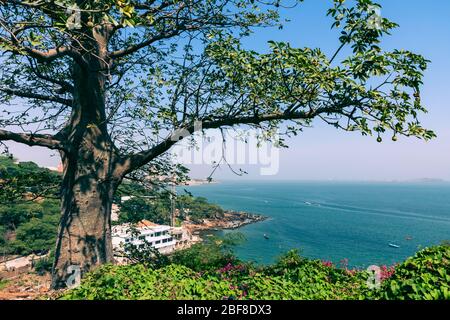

left=180, top=181, right=450, bottom=267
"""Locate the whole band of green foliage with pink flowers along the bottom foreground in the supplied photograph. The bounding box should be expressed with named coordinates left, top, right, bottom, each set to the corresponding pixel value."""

left=62, top=246, right=450, bottom=300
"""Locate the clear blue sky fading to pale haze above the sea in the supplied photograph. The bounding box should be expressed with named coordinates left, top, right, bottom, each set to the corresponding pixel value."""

left=6, top=0, right=450, bottom=180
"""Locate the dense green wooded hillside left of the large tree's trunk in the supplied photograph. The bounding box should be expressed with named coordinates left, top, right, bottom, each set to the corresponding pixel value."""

left=0, top=157, right=61, bottom=255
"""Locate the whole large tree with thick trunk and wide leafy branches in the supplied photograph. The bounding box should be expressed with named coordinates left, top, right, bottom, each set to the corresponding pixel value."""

left=0, top=0, right=434, bottom=288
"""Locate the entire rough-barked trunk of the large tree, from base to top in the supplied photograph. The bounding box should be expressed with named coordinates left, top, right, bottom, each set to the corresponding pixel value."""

left=52, top=33, right=122, bottom=289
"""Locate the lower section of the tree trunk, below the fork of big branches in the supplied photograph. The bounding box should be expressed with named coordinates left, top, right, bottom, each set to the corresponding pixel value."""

left=52, top=139, right=119, bottom=289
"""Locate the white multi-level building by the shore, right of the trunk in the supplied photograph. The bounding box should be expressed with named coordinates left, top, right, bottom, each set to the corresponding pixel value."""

left=112, top=220, right=177, bottom=254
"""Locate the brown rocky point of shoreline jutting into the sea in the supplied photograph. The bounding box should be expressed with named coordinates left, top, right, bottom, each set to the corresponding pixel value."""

left=183, top=211, right=268, bottom=234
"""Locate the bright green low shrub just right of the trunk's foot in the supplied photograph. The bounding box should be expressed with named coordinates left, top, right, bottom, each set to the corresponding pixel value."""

left=63, top=264, right=246, bottom=300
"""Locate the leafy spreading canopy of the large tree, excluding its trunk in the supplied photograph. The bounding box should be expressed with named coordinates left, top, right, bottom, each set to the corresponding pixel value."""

left=0, top=0, right=433, bottom=165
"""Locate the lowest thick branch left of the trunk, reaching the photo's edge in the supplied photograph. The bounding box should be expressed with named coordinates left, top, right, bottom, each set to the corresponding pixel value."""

left=0, top=129, right=65, bottom=150
